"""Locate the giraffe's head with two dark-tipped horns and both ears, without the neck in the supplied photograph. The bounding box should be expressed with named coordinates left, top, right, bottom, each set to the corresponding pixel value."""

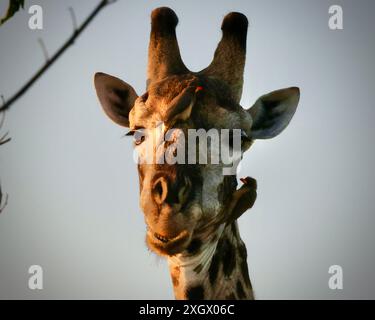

left=95, top=8, right=299, bottom=256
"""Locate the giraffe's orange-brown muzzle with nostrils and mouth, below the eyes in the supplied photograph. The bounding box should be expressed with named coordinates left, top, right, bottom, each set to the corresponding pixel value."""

left=138, top=164, right=201, bottom=255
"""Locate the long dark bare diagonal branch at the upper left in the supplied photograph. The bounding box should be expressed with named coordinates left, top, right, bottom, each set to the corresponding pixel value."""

left=0, top=0, right=115, bottom=112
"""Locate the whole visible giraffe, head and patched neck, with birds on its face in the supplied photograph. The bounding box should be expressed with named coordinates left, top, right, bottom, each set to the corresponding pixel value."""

left=94, top=7, right=300, bottom=299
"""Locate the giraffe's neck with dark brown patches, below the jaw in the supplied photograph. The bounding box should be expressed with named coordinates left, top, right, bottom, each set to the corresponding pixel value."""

left=168, top=221, right=253, bottom=300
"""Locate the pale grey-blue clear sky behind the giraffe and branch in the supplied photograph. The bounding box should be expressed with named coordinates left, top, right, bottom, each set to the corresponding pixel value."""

left=0, top=0, right=375, bottom=299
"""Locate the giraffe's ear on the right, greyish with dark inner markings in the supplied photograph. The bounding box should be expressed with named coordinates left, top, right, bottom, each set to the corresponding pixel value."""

left=248, top=87, right=300, bottom=139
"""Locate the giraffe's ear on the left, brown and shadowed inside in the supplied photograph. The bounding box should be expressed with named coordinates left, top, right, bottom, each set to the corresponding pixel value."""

left=94, top=72, right=138, bottom=127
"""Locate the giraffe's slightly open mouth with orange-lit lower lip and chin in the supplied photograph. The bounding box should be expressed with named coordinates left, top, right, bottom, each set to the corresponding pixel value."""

left=146, top=228, right=190, bottom=256
